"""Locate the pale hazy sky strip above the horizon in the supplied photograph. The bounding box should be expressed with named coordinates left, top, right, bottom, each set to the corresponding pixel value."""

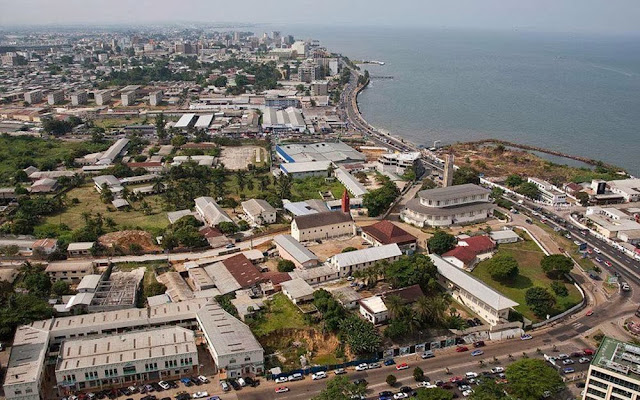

left=0, top=0, right=640, bottom=33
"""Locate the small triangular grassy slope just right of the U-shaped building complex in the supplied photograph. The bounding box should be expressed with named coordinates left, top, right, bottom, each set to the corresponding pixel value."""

left=251, top=293, right=307, bottom=337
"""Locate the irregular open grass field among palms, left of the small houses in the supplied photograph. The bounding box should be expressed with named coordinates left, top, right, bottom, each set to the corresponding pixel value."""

left=44, top=183, right=169, bottom=230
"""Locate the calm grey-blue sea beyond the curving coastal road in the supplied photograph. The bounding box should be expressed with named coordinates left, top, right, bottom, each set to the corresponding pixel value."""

left=270, top=26, right=640, bottom=175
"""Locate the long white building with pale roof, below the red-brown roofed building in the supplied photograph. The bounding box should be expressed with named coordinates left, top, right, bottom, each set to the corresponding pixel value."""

left=327, top=243, right=402, bottom=277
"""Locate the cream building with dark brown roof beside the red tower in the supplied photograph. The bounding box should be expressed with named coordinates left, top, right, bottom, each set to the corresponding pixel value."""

left=291, top=211, right=356, bottom=242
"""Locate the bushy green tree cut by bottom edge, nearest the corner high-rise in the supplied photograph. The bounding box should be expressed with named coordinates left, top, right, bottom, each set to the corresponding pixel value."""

left=505, top=358, right=564, bottom=400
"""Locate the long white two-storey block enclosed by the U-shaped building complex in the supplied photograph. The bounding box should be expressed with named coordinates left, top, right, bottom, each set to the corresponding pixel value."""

left=55, top=326, right=199, bottom=395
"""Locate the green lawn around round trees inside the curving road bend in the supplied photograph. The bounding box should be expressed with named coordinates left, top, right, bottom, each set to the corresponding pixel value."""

left=472, top=234, right=582, bottom=322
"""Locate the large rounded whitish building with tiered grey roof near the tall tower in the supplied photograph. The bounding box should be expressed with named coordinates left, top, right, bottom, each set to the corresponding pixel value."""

left=400, top=183, right=494, bottom=227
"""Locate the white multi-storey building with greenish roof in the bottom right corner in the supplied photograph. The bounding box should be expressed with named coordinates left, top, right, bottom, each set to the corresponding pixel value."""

left=582, top=337, right=640, bottom=400
